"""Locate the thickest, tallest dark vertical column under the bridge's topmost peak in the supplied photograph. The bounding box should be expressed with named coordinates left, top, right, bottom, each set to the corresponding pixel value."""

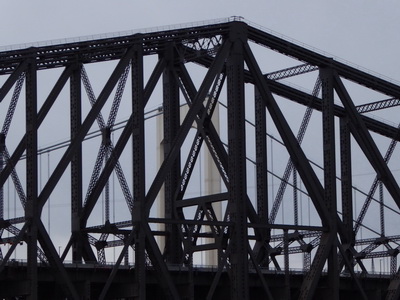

left=226, top=22, right=249, bottom=300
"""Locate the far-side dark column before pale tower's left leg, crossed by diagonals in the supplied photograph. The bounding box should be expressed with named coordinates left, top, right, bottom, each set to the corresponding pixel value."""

left=163, top=44, right=182, bottom=264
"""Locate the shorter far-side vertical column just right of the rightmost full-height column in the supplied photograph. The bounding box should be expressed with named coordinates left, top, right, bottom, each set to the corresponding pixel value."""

left=340, top=118, right=355, bottom=269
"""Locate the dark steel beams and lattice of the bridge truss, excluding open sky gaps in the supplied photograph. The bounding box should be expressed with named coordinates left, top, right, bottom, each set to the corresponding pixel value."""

left=0, top=19, right=400, bottom=300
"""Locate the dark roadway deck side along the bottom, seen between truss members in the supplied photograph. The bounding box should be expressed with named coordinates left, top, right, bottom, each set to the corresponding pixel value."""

left=0, top=262, right=391, bottom=300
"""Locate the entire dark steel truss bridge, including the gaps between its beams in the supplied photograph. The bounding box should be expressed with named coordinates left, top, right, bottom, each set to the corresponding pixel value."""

left=0, top=18, right=400, bottom=300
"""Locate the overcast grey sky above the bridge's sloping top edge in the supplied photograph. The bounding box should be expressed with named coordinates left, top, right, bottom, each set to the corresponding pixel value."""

left=0, top=0, right=400, bottom=81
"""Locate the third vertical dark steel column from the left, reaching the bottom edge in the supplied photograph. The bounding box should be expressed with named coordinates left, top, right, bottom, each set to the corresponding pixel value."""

left=132, top=43, right=147, bottom=300
